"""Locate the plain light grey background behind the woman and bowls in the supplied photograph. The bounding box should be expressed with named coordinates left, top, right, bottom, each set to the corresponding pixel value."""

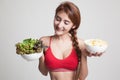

left=0, top=0, right=120, bottom=80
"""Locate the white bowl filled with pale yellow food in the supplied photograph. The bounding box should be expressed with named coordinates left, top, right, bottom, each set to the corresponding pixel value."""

left=84, top=39, right=108, bottom=53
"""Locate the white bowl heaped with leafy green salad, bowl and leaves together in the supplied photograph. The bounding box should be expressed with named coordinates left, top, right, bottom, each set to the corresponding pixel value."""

left=15, top=38, right=43, bottom=61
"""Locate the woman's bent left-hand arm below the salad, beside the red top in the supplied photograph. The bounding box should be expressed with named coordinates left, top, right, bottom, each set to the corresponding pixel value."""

left=38, top=55, right=48, bottom=76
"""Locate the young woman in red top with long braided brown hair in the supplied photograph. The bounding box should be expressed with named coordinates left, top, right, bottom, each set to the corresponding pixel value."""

left=39, top=1, right=101, bottom=80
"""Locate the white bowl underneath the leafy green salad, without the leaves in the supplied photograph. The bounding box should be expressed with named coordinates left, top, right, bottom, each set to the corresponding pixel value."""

left=21, top=51, right=43, bottom=61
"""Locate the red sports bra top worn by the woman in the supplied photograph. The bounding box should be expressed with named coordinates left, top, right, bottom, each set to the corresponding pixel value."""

left=45, top=38, right=78, bottom=71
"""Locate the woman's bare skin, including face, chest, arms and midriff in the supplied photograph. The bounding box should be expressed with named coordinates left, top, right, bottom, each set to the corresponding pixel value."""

left=38, top=11, right=102, bottom=80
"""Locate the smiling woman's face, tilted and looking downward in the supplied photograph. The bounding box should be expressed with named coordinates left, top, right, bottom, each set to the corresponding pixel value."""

left=54, top=11, right=73, bottom=35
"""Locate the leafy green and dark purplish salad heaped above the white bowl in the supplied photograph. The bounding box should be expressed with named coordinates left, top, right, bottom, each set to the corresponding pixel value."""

left=15, top=38, right=43, bottom=54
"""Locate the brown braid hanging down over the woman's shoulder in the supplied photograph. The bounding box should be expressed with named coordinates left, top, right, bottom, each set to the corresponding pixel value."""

left=70, top=29, right=81, bottom=61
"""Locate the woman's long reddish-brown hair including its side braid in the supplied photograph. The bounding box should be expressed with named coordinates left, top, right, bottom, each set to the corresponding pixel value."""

left=56, top=1, right=81, bottom=61
